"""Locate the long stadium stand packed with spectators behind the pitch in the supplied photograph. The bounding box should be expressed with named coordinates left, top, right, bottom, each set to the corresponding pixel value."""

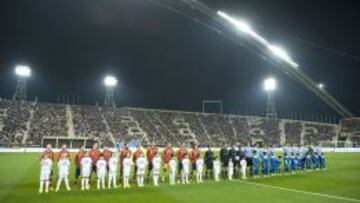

left=0, top=99, right=352, bottom=147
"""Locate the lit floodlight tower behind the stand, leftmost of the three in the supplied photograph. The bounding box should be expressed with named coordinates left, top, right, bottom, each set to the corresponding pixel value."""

left=13, top=65, right=31, bottom=101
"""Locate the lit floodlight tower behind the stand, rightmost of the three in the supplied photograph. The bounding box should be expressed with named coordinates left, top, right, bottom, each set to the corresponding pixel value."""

left=264, top=78, right=278, bottom=119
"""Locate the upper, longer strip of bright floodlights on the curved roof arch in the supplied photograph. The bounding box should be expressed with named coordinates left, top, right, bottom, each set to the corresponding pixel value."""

left=217, top=11, right=269, bottom=46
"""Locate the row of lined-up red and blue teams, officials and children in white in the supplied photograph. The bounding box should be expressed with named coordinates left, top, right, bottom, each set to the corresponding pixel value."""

left=39, top=144, right=326, bottom=193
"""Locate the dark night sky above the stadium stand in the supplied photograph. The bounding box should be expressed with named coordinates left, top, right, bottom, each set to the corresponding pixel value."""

left=0, top=0, right=360, bottom=115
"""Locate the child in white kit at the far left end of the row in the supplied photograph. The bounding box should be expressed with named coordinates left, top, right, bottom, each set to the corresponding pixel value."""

left=39, top=154, right=53, bottom=194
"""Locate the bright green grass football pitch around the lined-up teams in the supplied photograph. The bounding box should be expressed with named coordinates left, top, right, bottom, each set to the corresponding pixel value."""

left=0, top=153, right=360, bottom=203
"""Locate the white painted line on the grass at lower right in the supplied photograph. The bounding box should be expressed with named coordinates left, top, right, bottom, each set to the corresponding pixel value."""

left=241, top=181, right=360, bottom=202
